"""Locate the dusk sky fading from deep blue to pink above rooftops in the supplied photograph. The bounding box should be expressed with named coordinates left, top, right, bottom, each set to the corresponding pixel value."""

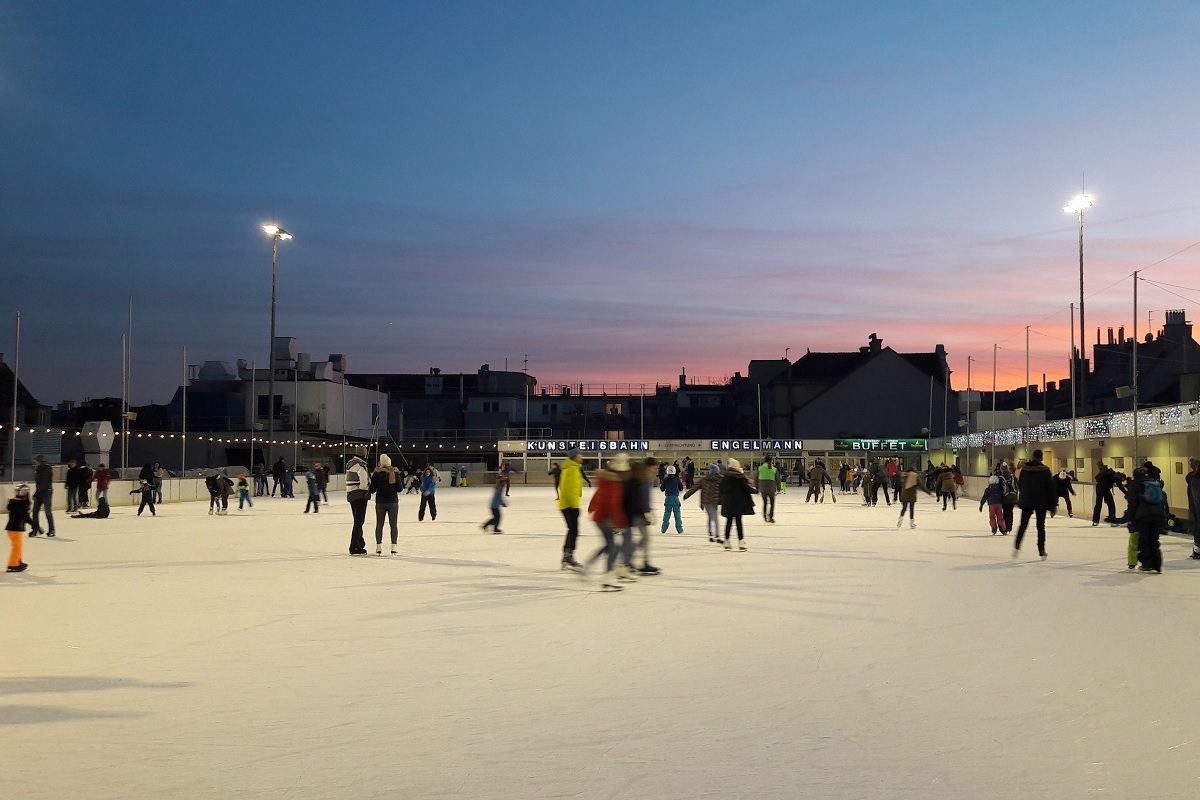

left=0, top=0, right=1200, bottom=404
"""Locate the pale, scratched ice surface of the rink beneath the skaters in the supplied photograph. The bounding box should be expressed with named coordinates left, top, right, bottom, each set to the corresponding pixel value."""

left=0, top=486, right=1200, bottom=800
